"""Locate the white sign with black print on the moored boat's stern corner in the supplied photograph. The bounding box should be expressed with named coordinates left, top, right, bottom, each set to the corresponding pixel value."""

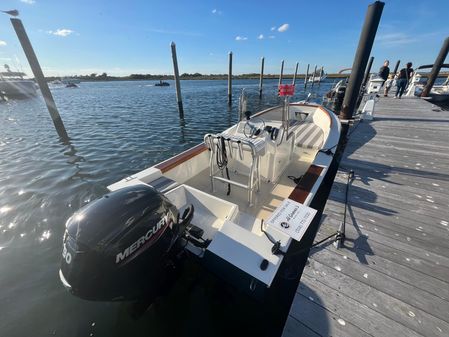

left=267, top=199, right=316, bottom=241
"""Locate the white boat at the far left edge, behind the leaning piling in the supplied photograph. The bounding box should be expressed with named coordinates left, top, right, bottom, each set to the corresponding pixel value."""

left=0, top=64, right=36, bottom=99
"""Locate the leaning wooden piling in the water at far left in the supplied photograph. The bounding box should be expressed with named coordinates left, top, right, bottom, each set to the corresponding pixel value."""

left=10, top=18, right=69, bottom=140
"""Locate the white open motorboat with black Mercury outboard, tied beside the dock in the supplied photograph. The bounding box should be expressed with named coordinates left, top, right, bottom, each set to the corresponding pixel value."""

left=60, top=96, right=340, bottom=301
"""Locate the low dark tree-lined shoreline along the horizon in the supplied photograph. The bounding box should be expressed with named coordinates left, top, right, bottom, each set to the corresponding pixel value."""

left=46, top=72, right=449, bottom=82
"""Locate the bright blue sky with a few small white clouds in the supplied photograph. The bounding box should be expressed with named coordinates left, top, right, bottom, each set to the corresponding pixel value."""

left=0, top=0, right=449, bottom=76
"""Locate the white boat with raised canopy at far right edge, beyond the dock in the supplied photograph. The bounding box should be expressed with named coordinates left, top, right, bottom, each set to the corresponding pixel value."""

left=404, top=64, right=449, bottom=102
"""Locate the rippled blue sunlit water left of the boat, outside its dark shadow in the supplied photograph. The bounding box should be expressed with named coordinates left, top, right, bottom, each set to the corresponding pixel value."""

left=0, top=80, right=332, bottom=337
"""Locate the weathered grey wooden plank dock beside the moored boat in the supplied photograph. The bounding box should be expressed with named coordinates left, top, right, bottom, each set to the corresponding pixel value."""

left=283, top=98, right=449, bottom=337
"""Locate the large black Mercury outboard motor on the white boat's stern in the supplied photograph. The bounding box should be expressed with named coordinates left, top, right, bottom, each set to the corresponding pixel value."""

left=59, top=185, right=193, bottom=301
